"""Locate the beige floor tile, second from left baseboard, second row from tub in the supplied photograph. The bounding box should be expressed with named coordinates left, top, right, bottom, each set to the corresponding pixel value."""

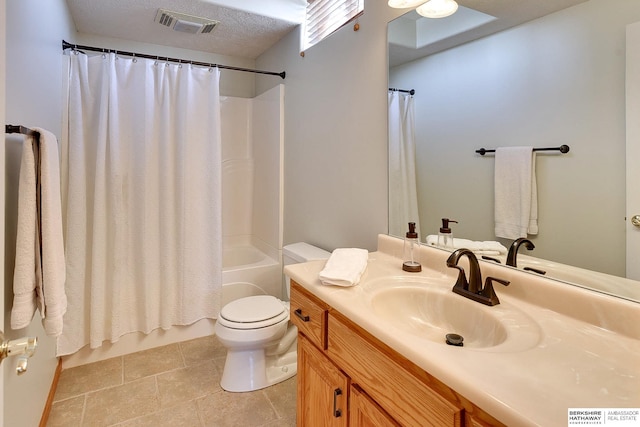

left=83, top=377, right=160, bottom=426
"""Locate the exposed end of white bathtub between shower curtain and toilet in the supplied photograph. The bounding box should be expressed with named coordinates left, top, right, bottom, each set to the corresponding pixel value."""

left=221, top=245, right=282, bottom=306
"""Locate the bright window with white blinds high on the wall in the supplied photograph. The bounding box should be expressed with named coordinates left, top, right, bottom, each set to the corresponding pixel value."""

left=302, top=0, right=364, bottom=51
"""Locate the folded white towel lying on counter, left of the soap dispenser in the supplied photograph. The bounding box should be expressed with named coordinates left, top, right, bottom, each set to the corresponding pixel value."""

left=319, top=248, right=369, bottom=286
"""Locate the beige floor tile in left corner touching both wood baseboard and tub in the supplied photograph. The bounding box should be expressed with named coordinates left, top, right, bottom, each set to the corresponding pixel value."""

left=54, top=357, right=122, bottom=401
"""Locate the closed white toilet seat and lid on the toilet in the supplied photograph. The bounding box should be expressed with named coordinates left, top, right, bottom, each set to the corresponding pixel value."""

left=218, top=295, right=289, bottom=329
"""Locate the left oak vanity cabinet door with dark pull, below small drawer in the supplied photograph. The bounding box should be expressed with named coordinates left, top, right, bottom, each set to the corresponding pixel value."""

left=297, top=334, right=349, bottom=427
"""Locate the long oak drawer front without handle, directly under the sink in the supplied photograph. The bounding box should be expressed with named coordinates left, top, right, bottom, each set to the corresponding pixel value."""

left=327, top=312, right=463, bottom=426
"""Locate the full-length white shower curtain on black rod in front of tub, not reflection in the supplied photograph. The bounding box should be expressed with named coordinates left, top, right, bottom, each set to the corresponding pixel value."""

left=57, top=53, right=222, bottom=355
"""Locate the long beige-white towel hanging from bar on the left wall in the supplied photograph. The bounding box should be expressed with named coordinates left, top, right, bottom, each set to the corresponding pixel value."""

left=11, top=128, right=67, bottom=336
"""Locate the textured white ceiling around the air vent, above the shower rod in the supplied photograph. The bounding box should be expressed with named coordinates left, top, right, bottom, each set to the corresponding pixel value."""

left=67, top=0, right=304, bottom=59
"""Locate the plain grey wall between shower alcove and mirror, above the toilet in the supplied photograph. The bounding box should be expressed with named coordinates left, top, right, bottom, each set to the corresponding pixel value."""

left=256, top=0, right=401, bottom=250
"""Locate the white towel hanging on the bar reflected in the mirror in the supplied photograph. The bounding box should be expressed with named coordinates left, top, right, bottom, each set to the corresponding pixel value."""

left=494, top=147, right=538, bottom=239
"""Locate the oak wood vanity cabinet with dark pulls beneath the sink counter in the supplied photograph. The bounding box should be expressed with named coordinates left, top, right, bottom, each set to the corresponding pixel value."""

left=291, top=280, right=502, bottom=427
